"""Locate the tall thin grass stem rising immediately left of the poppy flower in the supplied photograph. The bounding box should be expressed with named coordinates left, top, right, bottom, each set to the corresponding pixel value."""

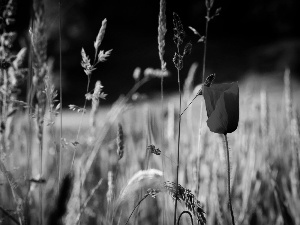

left=196, top=8, right=210, bottom=196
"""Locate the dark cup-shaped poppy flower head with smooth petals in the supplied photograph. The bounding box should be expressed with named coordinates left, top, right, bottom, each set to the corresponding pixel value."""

left=203, top=82, right=239, bottom=135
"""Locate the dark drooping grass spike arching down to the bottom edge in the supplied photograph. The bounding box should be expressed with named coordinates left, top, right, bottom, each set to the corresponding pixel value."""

left=164, top=181, right=206, bottom=225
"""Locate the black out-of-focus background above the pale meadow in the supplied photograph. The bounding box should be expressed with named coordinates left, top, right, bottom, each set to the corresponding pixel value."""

left=12, top=0, right=300, bottom=105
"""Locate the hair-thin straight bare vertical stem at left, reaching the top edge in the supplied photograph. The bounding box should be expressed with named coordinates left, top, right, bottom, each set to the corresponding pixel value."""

left=58, top=0, right=63, bottom=191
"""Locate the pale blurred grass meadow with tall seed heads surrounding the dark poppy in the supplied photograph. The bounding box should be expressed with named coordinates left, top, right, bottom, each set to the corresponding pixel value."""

left=0, top=0, right=300, bottom=225
